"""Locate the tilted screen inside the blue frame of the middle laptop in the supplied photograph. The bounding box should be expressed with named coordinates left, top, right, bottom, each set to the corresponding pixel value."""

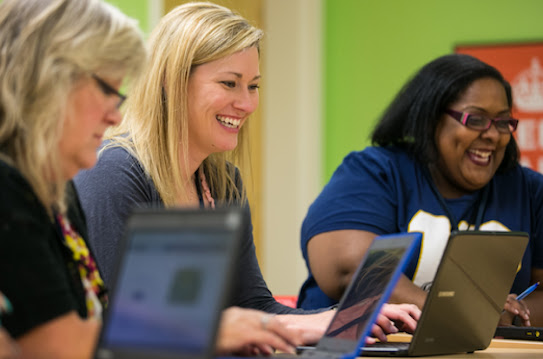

left=325, top=247, right=405, bottom=341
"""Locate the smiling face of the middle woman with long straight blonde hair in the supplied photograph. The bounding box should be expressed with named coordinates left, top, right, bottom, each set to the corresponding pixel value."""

left=188, top=47, right=260, bottom=162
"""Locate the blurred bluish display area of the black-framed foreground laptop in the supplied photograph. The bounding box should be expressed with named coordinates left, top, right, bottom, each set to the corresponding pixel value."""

left=103, top=232, right=228, bottom=352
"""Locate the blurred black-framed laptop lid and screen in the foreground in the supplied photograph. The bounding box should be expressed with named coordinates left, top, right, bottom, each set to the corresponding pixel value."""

left=95, top=208, right=248, bottom=359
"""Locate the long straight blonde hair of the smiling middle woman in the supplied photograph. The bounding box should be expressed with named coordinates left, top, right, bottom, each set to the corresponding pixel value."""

left=106, top=2, right=262, bottom=206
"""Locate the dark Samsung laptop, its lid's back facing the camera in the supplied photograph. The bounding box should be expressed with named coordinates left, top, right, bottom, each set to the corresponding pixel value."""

left=362, top=231, right=528, bottom=356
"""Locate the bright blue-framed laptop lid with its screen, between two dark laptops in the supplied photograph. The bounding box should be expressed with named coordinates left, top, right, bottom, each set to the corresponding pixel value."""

left=313, top=233, right=422, bottom=358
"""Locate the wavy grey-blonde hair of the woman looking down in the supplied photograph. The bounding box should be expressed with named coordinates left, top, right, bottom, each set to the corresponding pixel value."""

left=0, top=0, right=146, bottom=214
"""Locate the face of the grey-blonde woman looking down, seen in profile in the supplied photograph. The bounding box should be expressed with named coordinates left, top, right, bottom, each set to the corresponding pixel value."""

left=59, top=74, right=121, bottom=179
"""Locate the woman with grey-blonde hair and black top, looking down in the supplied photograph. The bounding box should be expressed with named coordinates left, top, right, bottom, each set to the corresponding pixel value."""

left=0, top=0, right=146, bottom=359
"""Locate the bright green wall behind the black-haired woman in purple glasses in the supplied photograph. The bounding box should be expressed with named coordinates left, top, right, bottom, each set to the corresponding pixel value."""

left=323, top=0, right=543, bottom=180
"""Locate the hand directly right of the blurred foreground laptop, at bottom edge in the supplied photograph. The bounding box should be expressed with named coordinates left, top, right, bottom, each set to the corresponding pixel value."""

left=216, top=307, right=302, bottom=355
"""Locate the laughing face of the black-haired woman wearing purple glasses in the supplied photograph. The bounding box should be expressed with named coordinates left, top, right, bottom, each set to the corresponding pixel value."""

left=430, top=78, right=511, bottom=198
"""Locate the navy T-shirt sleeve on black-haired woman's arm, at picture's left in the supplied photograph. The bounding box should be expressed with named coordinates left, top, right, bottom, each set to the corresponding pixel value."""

left=301, top=148, right=404, bottom=261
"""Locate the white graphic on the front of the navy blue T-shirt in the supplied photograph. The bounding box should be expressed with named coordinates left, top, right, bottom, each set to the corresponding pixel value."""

left=408, top=210, right=509, bottom=288
